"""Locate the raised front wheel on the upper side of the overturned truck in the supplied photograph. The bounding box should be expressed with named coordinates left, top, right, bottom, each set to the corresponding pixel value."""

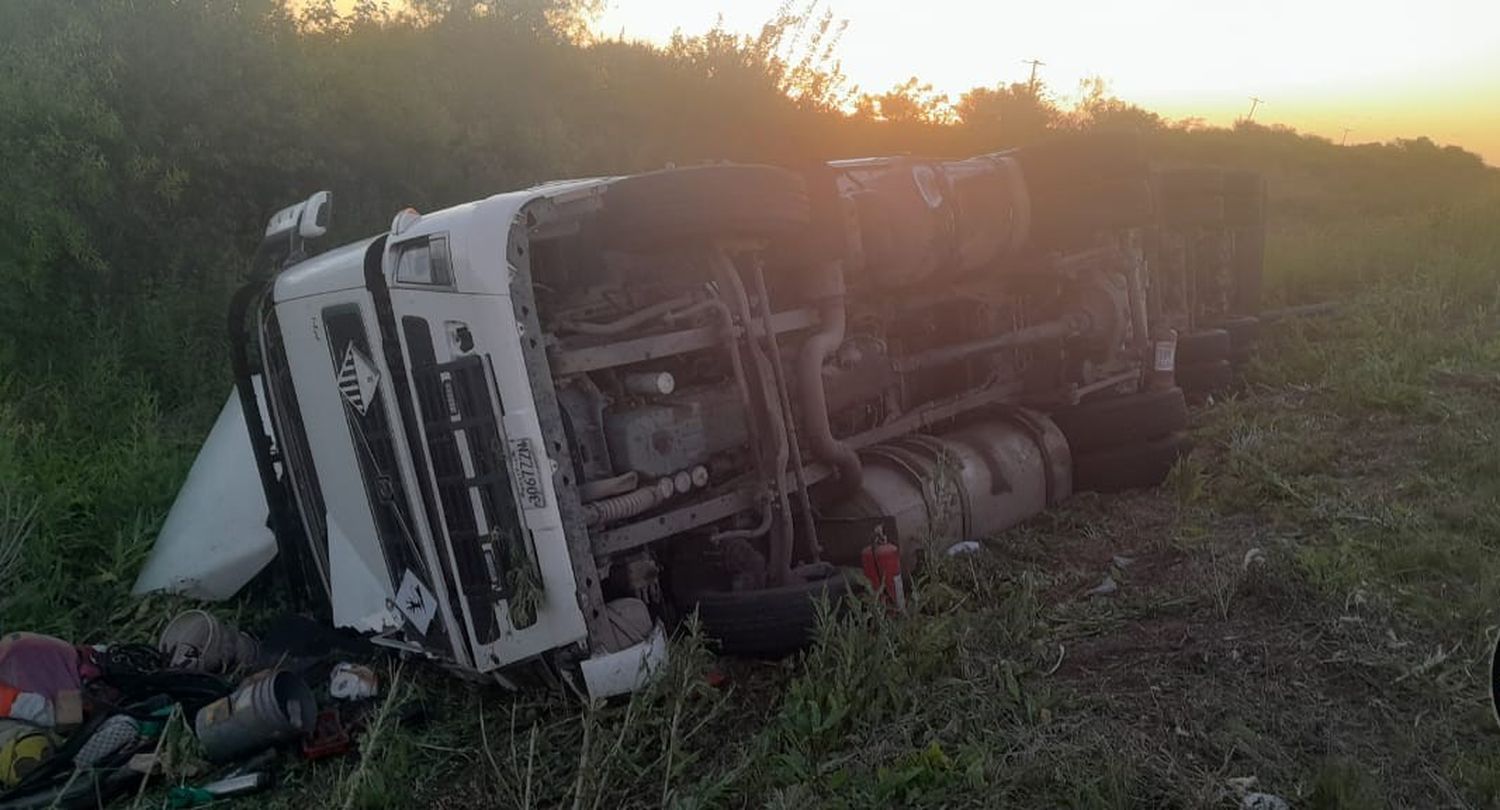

left=599, top=164, right=813, bottom=249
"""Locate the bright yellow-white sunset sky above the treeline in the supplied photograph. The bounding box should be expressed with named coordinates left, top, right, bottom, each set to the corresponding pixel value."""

left=597, top=0, right=1500, bottom=165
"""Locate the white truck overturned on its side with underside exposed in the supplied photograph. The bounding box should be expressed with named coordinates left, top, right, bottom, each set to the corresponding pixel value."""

left=138, top=134, right=1260, bottom=695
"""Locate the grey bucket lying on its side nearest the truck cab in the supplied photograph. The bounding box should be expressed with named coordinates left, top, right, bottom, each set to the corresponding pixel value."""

left=194, top=669, right=318, bottom=762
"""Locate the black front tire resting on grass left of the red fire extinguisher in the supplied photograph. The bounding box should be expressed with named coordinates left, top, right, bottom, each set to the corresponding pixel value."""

left=683, top=572, right=854, bottom=659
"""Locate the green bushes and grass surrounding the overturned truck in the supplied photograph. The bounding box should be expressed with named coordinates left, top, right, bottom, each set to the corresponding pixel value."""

left=0, top=0, right=1500, bottom=807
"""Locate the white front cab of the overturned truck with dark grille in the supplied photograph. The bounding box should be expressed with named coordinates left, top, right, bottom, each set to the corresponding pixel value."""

left=251, top=180, right=660, bottom=693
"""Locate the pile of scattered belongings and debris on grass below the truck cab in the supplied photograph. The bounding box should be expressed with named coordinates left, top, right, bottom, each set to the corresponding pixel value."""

left=0, top=611, right=393, bottom=807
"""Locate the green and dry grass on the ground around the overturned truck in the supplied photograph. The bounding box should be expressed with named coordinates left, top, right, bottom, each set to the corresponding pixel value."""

left=0, top=188, right=1500, bottom=809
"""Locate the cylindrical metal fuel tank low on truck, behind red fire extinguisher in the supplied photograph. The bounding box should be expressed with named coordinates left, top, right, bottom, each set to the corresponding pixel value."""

left=824, top=410, right=1073, bottom=570
